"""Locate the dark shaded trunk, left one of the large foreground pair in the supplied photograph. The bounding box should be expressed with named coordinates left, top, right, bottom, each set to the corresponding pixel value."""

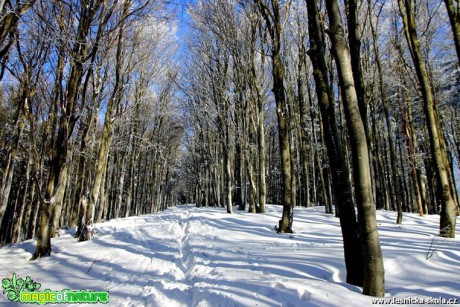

left=307, top=1, right=363, bottom=286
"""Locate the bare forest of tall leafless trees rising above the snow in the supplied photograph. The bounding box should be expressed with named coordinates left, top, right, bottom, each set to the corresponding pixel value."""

left=0, top=0, right=460, bottom=296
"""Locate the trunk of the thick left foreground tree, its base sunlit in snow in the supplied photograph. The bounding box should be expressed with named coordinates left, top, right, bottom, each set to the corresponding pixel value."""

left=32, top=1, right=114, bottom=259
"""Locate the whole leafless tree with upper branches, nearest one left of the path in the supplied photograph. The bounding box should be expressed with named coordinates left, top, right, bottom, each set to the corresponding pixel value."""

left=32, top=1, right=125, bottom=259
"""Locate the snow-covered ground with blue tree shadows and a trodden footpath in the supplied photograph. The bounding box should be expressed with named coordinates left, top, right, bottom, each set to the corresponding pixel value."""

left=0, top=206, right=460, bottom=307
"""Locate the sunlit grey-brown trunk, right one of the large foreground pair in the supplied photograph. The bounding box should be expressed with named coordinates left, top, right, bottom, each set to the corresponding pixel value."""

left=326, top=0, right=385, bottom=297
